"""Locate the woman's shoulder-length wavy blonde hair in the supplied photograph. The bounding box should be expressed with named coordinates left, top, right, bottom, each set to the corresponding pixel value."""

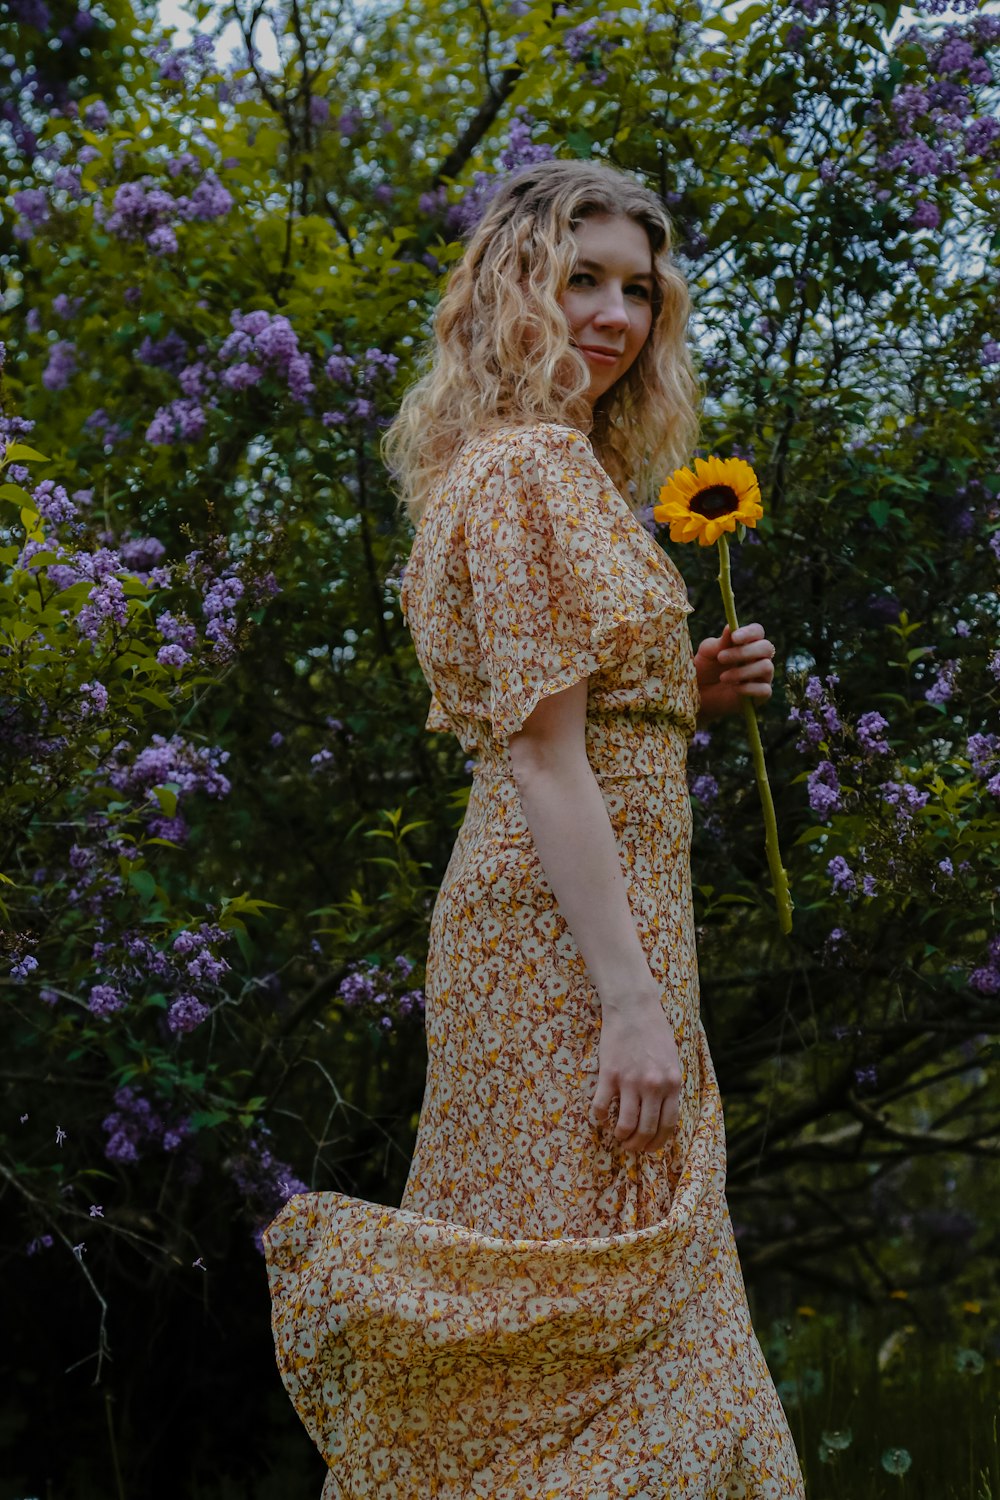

left=381, top=161, right=703, bottom=525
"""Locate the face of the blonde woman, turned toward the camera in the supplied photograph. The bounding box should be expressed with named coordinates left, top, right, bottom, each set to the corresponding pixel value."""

left=559, top=215, right=654, bottom=405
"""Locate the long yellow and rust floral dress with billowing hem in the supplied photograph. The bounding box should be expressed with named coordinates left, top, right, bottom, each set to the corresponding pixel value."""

left=264, top=423, right=805, bottom=1500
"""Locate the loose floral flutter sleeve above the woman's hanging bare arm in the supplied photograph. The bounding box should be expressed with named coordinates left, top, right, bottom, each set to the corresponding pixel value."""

left=465, top=425, right=693, bottom=744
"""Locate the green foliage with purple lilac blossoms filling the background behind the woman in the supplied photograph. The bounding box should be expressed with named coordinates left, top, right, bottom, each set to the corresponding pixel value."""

left=0, top=0, right=1000, bottom=1500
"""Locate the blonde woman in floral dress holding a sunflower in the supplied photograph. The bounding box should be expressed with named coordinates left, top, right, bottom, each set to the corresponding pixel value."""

left=265, top=162, right=804, bottom=1500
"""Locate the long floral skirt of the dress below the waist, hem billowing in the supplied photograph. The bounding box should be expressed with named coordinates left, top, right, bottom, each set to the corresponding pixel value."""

left=264, top=714, right=805, bottom=1500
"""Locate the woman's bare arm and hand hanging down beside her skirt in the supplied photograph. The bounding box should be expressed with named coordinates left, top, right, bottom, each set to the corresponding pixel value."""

left=510, top=678, right=681, bottom=1151
